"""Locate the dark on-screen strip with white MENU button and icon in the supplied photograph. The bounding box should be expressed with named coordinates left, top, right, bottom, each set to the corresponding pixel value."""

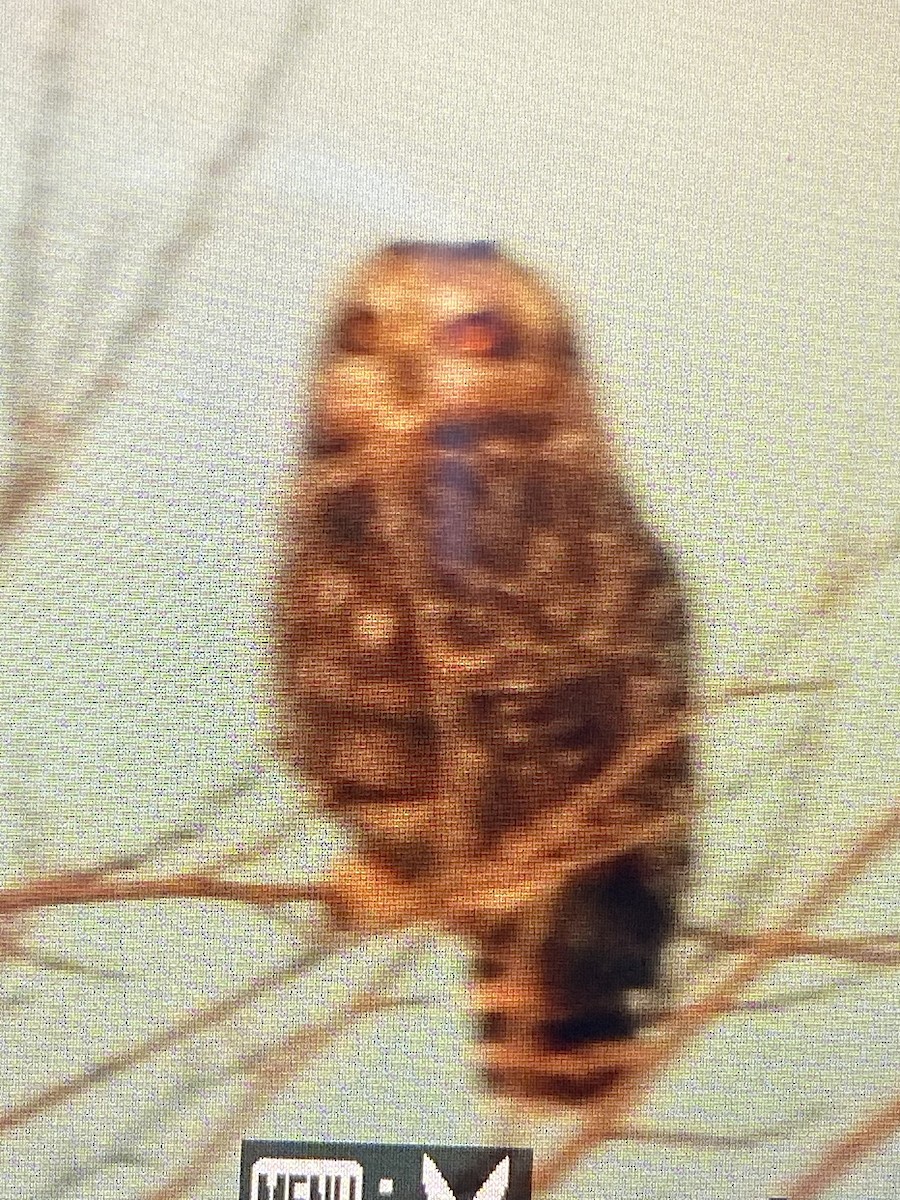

left=240, top=1141, right=532, bottom=1200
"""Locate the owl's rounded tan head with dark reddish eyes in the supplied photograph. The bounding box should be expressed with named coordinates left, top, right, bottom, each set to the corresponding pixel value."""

left=312, top=242, right=589, bottom=452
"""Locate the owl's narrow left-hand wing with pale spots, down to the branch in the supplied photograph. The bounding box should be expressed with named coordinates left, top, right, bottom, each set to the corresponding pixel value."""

left=272, top=451, right=448, bottom=930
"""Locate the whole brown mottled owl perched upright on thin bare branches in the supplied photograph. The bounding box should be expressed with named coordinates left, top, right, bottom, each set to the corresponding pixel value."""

left=272, top=242, right=692, bottom=1103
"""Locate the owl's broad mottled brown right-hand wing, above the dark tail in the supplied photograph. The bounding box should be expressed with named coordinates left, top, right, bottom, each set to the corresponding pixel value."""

left=431, top=415, right=691, bottom=888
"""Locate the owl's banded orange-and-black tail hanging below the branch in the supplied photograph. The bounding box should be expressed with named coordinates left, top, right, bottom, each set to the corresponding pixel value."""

left=475, top=854, right=674, bottom=1103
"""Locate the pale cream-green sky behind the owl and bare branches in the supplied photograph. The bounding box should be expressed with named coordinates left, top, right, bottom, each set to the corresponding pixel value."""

left=0, top=0, right=900, bottom=1200
